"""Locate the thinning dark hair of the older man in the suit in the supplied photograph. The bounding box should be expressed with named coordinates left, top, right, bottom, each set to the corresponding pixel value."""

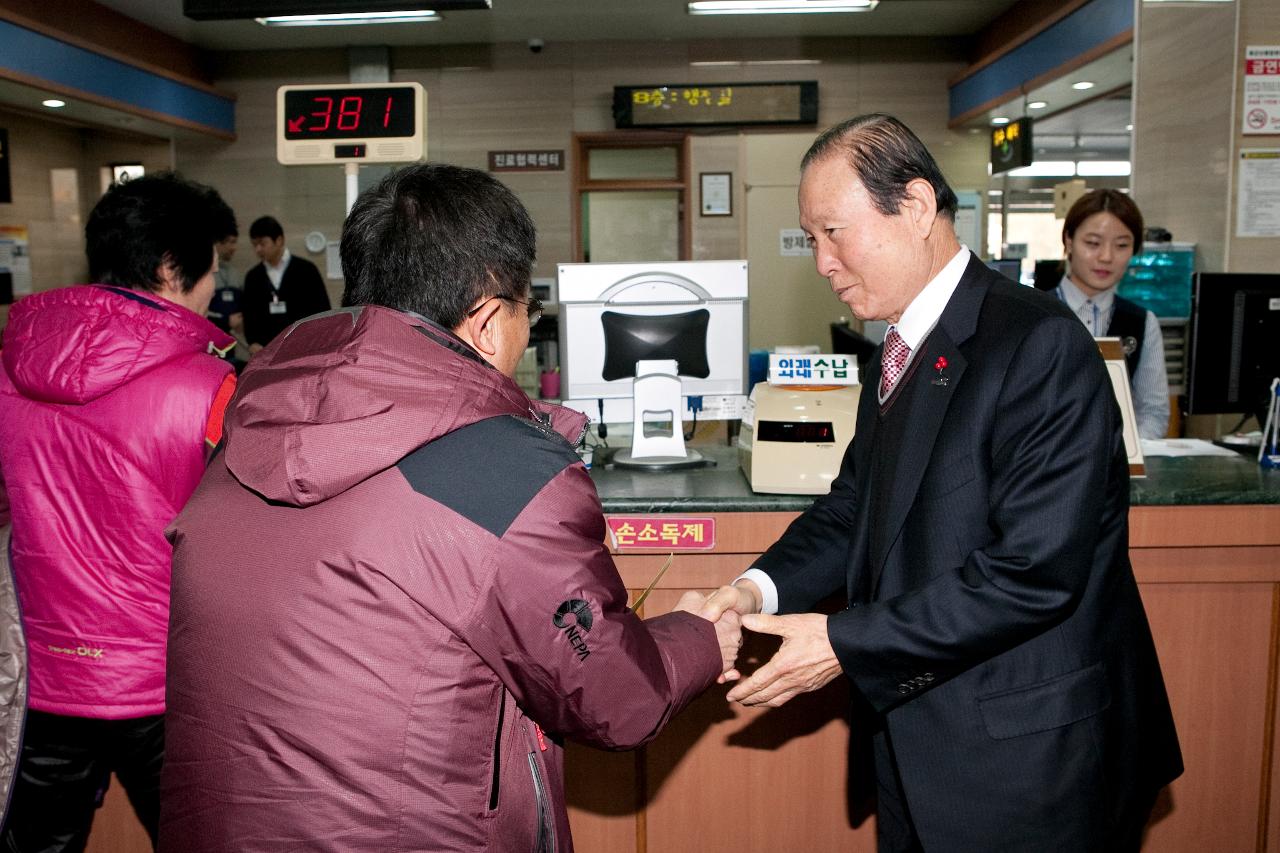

left=800, top=113, right=959, bottom=222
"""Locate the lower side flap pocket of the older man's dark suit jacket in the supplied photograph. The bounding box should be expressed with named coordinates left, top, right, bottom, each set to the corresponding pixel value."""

left=978, top=661, right=1111, bottom=740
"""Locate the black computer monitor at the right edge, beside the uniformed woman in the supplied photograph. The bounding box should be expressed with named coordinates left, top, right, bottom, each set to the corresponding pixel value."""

left=1187, top=273, right=1280, bottom=423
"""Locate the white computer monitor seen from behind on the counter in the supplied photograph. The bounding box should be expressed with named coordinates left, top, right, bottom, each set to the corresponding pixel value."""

left=557, top=260, right=748, bottom=467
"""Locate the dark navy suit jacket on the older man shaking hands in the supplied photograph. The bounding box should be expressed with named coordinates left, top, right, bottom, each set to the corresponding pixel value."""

left=755, top=257, right=1181, bottom=853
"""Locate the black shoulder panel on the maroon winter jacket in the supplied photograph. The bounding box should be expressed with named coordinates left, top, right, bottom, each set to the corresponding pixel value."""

left=397, top=415, right=579, bottom=537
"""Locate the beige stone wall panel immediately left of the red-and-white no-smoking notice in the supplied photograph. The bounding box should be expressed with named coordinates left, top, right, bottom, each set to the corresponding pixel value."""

left=1129, top=3, right=1236, bottom=270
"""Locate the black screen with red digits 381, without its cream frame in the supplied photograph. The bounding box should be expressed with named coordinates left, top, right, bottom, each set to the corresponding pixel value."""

left=284, top=86, right=416, bottom=141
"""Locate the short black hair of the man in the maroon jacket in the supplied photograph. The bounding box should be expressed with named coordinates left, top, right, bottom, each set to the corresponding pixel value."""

left=340, top=163, right=536, bottom=329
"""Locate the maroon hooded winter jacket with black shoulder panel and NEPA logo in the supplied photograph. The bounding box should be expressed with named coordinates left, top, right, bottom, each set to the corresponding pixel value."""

left=160, top=307, right=721, bottom=853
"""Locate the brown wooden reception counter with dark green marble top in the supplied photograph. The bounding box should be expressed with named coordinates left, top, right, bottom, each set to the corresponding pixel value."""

left=568, top=447, right=1280, bottom=853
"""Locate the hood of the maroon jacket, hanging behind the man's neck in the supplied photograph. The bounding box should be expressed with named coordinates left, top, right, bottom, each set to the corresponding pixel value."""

left=224, top=306, right=586, bottom=506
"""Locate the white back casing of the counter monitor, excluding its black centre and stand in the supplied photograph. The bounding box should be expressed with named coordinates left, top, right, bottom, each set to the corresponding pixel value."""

left=557, top=260, right=748, bottom=423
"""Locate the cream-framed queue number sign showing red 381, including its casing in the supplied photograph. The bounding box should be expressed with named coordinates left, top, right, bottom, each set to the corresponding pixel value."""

left=275, top=83, right=426, bottom=165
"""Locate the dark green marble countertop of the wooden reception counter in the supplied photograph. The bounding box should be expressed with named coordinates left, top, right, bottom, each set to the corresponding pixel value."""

left=591, top=444, right=1280, bottom=514
